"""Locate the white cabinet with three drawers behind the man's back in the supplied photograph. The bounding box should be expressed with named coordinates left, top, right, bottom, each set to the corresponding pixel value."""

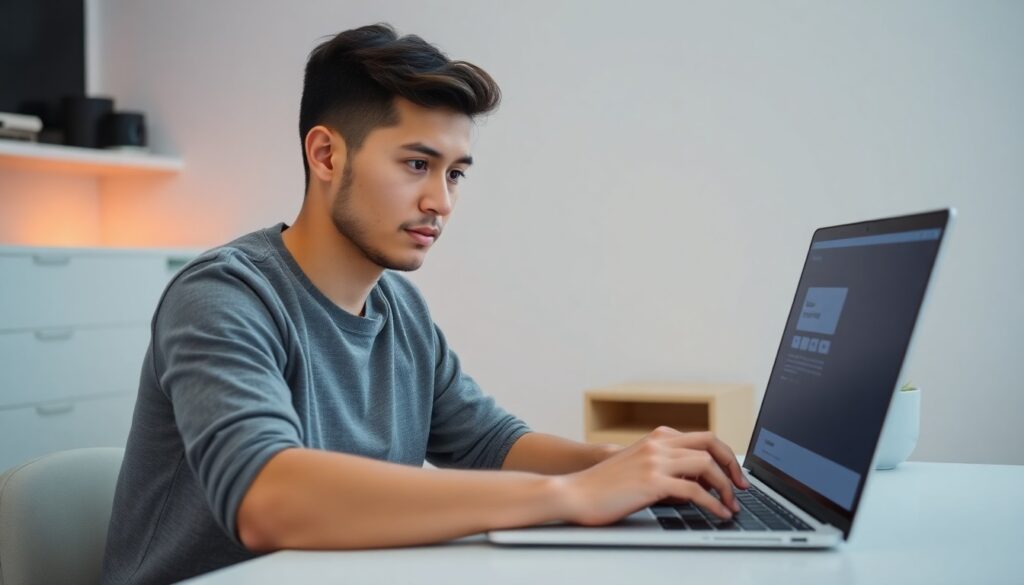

left=0, top=246, right=199, bottom=470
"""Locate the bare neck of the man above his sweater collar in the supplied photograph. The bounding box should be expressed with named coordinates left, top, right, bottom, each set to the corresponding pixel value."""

left=282, top=207, right=384, bottom=317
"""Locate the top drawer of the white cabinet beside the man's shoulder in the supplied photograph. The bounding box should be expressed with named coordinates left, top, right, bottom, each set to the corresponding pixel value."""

left=0, top=251, right=181, bottom=330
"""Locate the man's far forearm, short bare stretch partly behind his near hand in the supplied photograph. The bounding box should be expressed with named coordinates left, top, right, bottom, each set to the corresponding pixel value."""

left=502, top=432, right=622, bottom=475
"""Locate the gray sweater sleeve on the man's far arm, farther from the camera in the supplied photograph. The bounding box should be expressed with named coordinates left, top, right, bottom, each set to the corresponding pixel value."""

left=427, top=325, right=529, bottom=469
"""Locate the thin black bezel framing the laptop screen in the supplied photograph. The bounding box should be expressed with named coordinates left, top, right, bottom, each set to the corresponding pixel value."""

left=743, top=208, right=953, bottom=540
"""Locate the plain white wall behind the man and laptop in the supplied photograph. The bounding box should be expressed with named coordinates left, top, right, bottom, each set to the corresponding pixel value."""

left=98, top=0, right=1024, bottom=463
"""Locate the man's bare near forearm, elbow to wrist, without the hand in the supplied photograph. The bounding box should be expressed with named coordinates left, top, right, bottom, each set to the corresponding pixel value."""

left=238, top=449, right=569, bottom=551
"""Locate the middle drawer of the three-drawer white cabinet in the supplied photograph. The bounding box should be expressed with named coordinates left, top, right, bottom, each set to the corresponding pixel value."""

left=0, top=325, right=150, bottom=407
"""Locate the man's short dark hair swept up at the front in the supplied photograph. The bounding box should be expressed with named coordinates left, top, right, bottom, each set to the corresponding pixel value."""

left=299, top=24, right=501, bottom=189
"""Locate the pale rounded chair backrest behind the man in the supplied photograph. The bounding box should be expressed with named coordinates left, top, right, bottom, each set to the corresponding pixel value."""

left=0, top=448, right=124, bottom=585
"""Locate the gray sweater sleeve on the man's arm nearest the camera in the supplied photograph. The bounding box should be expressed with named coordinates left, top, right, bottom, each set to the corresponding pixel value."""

left=154, top=256, right=302, bottom=544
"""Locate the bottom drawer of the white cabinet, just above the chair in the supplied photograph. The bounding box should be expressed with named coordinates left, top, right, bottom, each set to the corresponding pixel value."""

left=0, top=392, right=135, bottom=470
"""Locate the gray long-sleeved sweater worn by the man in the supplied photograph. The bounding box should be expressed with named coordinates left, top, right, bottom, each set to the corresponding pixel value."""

left=103, top=224, right=528, bottom=584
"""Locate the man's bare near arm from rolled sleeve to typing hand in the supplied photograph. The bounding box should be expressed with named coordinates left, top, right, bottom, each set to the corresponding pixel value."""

left=237, top=427, right=746, bottom=552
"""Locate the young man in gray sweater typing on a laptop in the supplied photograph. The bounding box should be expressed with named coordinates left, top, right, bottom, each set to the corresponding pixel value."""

left=103, top=26, right=746, bottom=583
